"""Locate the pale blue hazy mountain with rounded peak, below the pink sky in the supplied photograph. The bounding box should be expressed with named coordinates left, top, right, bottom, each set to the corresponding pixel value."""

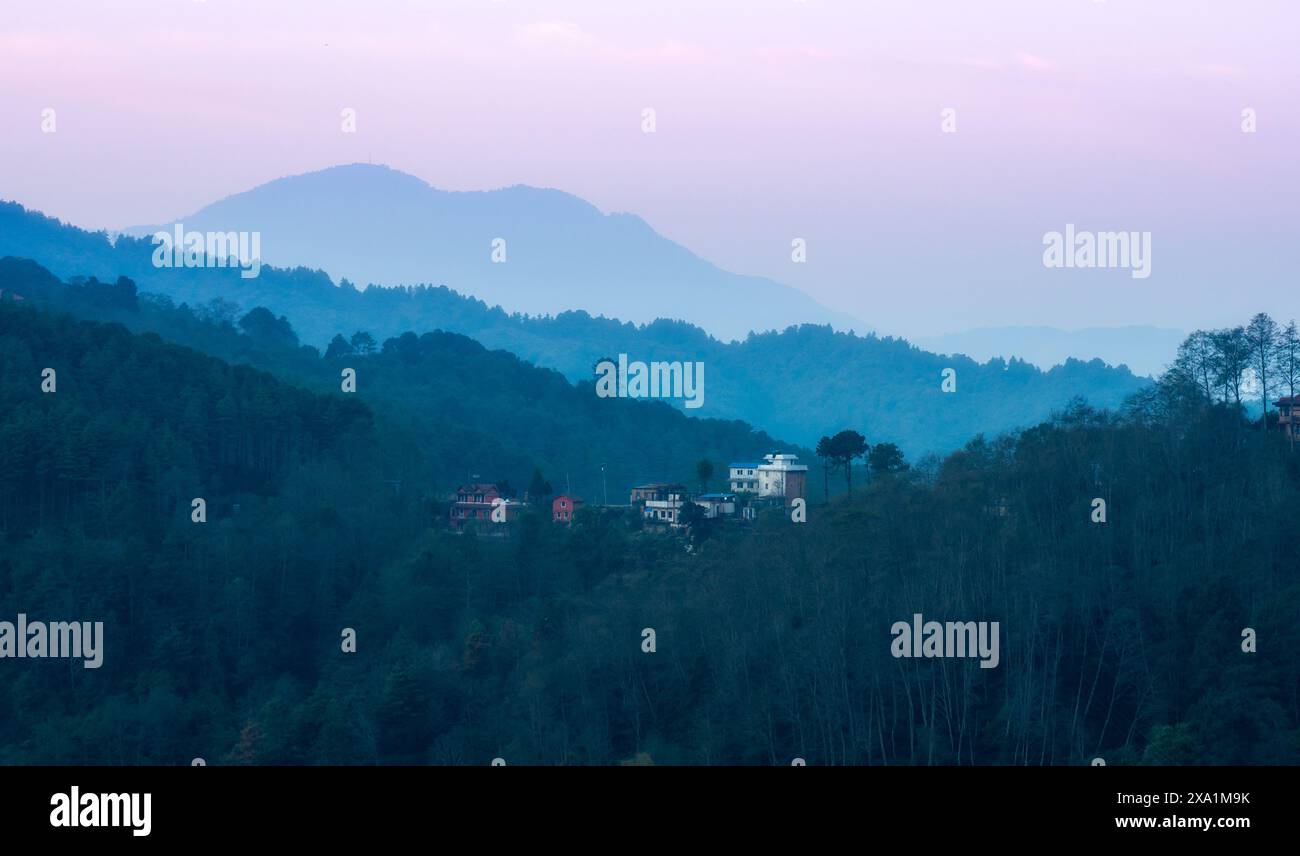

left=124, top=164, right=865, bottom=340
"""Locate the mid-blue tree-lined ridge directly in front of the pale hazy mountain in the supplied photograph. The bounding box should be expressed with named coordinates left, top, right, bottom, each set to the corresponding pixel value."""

left=0, top=203, right=1148, bottom=457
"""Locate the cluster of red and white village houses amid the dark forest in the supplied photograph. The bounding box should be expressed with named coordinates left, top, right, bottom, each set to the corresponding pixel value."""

left=447, top=451, right=809, bottom=531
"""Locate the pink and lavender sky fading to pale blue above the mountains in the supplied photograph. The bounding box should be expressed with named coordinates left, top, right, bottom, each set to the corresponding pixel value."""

left=0, top=0, right=1300, bottom=336
